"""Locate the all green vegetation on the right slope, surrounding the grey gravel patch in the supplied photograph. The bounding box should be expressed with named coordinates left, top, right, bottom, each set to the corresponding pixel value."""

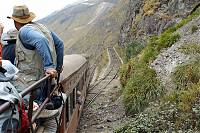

left=116, top=3, right=200, bottom=133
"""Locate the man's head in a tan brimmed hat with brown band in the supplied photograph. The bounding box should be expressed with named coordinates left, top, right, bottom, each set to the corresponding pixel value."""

left=7, top=5, right=35, bottom=30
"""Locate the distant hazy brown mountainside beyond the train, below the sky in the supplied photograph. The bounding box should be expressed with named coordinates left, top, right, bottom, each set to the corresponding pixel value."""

left=40, top=0, right=126, bottom=56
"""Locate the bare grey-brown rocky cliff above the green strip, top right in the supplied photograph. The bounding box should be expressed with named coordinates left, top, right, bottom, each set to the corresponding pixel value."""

left=119, top=0, right=200, bottom=46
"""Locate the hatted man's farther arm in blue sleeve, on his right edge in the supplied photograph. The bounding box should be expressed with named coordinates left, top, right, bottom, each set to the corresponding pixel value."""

left=51, top=32, right=64, bottom=72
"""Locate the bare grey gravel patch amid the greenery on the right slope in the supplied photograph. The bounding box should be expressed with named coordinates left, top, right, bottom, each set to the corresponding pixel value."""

left=151, top=16, right=200, bottom=90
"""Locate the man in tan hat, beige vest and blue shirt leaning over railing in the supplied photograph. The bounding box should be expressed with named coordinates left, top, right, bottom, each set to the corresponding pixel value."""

left=8, top=5, right=64, bottom=119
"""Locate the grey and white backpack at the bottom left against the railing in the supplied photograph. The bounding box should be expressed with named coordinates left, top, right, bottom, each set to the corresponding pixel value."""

left=0, top=82, right=22, bottom=133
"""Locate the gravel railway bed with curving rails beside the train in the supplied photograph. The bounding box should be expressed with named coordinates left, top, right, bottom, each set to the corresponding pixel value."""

left=77, top=48, right=122, bottom=133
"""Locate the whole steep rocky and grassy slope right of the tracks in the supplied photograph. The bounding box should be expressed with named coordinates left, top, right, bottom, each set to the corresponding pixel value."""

left=116, top=0, right=200, bottom=133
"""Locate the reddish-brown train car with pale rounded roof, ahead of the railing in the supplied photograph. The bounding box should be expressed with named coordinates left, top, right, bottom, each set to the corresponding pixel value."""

left=57, top=55, right=90, bottom=133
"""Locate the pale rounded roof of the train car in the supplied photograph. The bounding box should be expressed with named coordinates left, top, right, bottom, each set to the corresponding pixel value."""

left=60, top=54, right=87, bottom=81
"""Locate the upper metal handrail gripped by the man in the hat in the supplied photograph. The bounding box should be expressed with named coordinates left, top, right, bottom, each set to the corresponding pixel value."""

left=0, top=75, right=50, bottom=115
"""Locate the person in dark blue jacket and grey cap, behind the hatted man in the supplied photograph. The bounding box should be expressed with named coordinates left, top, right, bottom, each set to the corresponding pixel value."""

left=2, top=29, right=18, bottom=64
